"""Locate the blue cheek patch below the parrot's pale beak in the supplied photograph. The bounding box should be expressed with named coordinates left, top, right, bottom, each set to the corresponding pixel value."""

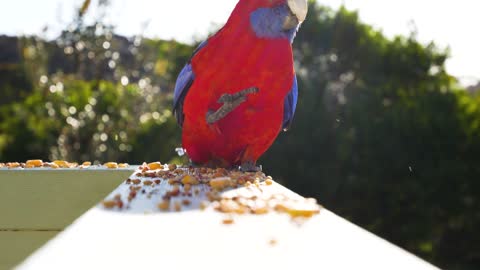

left=250, top=5, right=298, bottom=43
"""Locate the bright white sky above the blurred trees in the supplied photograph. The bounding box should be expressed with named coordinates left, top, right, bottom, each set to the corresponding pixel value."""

left=0, top=0, right=480, bottom=84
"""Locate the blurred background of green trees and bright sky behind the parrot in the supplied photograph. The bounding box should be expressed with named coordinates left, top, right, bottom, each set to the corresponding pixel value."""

left=0, top=0, right=480, bottom=269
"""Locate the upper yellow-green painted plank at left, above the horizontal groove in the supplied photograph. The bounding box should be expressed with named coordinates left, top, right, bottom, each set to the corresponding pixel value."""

left=0, top=167, right=134, bottom=230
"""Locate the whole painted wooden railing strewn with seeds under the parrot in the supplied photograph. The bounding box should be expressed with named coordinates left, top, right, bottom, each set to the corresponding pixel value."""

left=0, top=167, right=437, bottom=270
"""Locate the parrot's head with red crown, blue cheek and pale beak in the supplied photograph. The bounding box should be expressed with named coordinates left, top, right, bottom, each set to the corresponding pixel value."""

left=230, top=0, right=308, bottom=42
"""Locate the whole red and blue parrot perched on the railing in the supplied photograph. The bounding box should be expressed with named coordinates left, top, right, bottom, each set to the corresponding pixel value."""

left=173, top=0, right=308, bottom=171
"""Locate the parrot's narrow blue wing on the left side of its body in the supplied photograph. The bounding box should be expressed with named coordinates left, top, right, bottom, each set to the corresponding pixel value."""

left=173, top=41, right=207, bottom=126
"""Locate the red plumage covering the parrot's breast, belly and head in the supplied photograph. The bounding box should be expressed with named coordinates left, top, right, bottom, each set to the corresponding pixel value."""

left=182, top=0, right=294, bottom=166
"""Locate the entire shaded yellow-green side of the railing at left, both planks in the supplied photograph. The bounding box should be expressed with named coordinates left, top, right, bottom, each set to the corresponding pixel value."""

left=0, top=166, right=135, bottom=269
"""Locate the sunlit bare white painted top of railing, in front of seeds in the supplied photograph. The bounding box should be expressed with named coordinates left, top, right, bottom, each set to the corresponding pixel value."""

left=18, top=171, right=437, bottom=270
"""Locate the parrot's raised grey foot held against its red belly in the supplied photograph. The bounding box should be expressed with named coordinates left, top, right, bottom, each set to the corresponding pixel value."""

left=207, top=87, right=259, bottom=124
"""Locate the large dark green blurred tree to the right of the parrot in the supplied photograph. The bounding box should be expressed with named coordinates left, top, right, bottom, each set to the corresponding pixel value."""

left=263, top=2, right=480, bottom=269
